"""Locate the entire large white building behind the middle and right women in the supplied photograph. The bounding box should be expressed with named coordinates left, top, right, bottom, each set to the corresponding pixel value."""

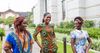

left=34, top=0, right=100, bottom=24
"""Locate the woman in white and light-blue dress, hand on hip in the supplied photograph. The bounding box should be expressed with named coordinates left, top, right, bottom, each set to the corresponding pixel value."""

left=71, top=17, right=92, bottom=53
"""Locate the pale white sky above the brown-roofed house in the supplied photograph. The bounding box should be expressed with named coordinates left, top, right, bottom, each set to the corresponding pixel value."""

left=0, top=0, right=37, bottom=12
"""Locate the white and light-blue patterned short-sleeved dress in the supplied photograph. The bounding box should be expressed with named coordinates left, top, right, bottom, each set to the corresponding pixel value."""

left=71, top=29, right=89, bottom=53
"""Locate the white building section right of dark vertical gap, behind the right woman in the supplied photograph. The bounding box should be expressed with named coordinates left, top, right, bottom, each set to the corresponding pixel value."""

left=65, top=0, right=100, bottom=27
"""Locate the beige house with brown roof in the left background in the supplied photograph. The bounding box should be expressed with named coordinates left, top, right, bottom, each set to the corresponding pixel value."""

left=0, top=9, right=28, bottom=29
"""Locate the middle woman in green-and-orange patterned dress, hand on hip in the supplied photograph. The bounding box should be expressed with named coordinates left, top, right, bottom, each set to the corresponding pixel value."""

left=33, top=13, right=57, bottom=53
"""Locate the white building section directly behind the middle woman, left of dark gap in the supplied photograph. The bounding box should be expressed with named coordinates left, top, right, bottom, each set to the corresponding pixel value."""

left=33, top=0, right=62, bottom=24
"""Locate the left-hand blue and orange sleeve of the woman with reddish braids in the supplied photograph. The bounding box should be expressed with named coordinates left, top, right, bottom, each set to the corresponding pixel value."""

left=3, top=34, right=13, bottom=49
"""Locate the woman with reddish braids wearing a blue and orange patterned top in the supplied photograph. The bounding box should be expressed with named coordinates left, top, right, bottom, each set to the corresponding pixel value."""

left=4, top=16, right=33, bottom=53
